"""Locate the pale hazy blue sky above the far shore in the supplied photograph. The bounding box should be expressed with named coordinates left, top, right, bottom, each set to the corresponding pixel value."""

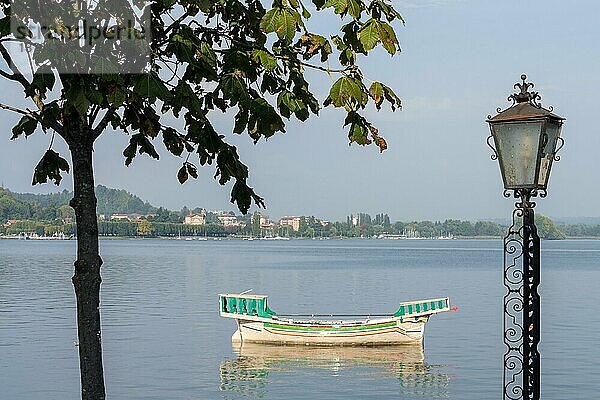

left=0, top=0, right=600, bottom=220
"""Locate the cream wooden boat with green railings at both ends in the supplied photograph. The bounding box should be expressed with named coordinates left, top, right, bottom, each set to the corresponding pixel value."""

left=219, top=294, right=450, bottom=346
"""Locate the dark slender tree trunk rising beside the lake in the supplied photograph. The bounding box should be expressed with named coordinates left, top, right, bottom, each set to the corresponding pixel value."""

left=69, top=135, right=106, bottom=400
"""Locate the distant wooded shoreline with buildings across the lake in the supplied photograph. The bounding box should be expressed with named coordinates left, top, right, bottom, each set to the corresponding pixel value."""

left=0, top=186, right=600, bottom=239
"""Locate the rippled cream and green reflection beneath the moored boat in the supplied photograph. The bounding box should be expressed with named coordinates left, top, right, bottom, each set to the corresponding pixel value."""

left=220, top=343, right=450, bottom=399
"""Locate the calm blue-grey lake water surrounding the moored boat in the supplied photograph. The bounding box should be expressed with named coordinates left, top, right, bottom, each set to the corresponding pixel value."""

left=0, top=240, right=600, bottom=400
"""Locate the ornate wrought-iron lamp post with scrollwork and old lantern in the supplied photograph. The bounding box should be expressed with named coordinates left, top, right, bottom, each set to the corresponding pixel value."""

left=486, top=75, right=564, bottom=400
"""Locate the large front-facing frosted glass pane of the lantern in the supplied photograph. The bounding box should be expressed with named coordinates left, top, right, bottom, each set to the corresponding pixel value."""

left=492, top=121, right=544, bottom=189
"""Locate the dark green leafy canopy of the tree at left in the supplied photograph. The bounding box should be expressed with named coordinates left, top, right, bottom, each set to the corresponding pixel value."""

left=0, top=0, right=403, bottom=212
